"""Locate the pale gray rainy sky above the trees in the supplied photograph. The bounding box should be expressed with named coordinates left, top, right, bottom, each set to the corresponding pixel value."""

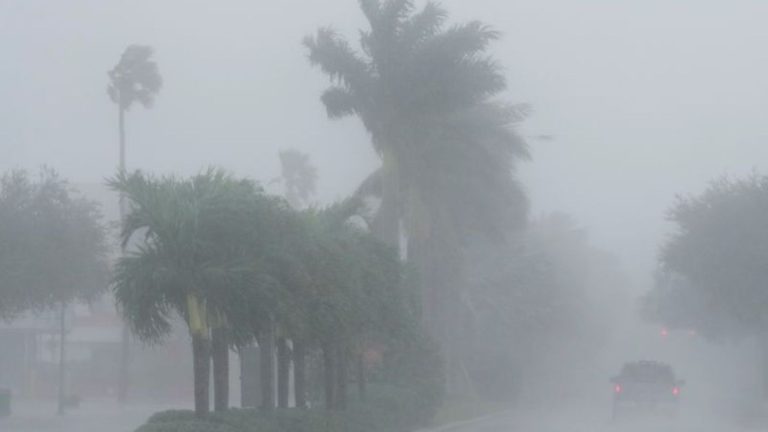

left=0, top=0, right=768, bottom=285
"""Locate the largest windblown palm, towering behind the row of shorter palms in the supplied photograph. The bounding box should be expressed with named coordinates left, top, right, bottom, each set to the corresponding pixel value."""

left=304, top=0, right=528, bottom=392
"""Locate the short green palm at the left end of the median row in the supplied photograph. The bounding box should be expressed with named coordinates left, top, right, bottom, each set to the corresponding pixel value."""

left=109, top=171, right=278, bottom=416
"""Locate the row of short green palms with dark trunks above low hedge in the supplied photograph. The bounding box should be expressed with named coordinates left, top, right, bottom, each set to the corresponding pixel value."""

left=109, top=169, right=418, bottom=416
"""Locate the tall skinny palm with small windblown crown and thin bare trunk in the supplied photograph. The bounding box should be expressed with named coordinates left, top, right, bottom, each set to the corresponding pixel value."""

left=107, top=45, right=163, bottom=402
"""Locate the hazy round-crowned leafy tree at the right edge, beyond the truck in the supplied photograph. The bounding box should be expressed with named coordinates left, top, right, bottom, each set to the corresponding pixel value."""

left=645, top=174, right=768, bottom=394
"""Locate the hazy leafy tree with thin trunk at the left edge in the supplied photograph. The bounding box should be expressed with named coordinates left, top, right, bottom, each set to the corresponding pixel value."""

left=0, top=169, right=109, bottom=413
